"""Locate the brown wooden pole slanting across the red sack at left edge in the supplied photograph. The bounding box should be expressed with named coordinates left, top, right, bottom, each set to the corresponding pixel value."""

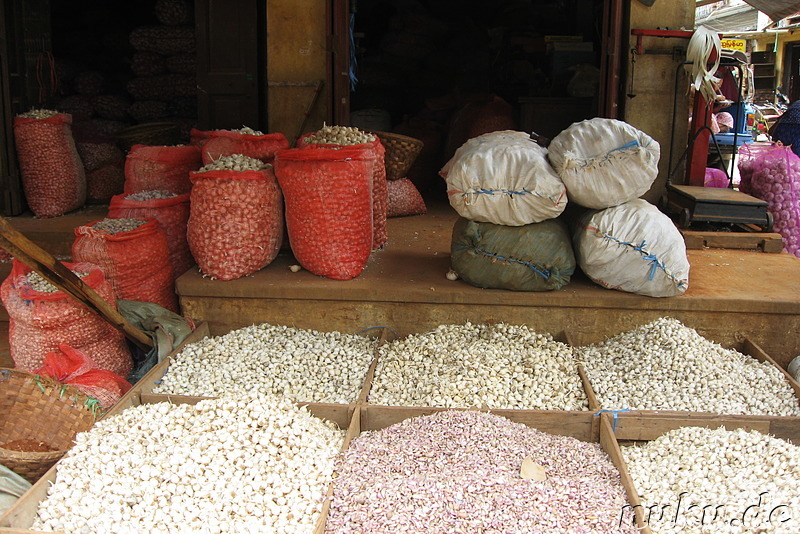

left=0, top=217, right=153, bottom=352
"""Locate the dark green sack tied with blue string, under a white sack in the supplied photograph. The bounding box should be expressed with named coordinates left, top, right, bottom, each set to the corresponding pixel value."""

left=450, top=217, right=575, bottom=291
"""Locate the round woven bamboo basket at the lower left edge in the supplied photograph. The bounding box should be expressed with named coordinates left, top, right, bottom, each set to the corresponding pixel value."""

left=0, top=368, right=103, bottom=483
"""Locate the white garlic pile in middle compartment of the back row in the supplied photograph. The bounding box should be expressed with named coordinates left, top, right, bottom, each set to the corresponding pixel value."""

left=369, top=322, right=588, bottom=410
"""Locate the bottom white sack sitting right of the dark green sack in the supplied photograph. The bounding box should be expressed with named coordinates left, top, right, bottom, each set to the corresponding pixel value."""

left=573, top=198, right=689, bottom=297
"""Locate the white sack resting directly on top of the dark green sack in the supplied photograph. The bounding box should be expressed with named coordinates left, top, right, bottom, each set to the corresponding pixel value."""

left=439, top=130, right=567, bottom=226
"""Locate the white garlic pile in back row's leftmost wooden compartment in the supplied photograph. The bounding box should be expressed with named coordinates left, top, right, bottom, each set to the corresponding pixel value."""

left=153, top=323, right=376, bottom=404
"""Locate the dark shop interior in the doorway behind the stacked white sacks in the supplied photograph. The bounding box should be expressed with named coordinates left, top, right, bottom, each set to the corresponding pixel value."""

left=351, top=0, right=603, bottom=200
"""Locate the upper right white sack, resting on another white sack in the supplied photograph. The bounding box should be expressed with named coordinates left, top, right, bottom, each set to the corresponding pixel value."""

left=547, top=118, right=661, bottom=209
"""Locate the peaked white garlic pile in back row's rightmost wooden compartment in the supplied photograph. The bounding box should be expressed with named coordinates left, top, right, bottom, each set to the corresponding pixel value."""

left=576, top=317, right=800, bottom=416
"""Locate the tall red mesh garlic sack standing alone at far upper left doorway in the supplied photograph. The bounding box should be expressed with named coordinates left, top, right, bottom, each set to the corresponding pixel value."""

left=14, top=110, right=86, bottom=218
